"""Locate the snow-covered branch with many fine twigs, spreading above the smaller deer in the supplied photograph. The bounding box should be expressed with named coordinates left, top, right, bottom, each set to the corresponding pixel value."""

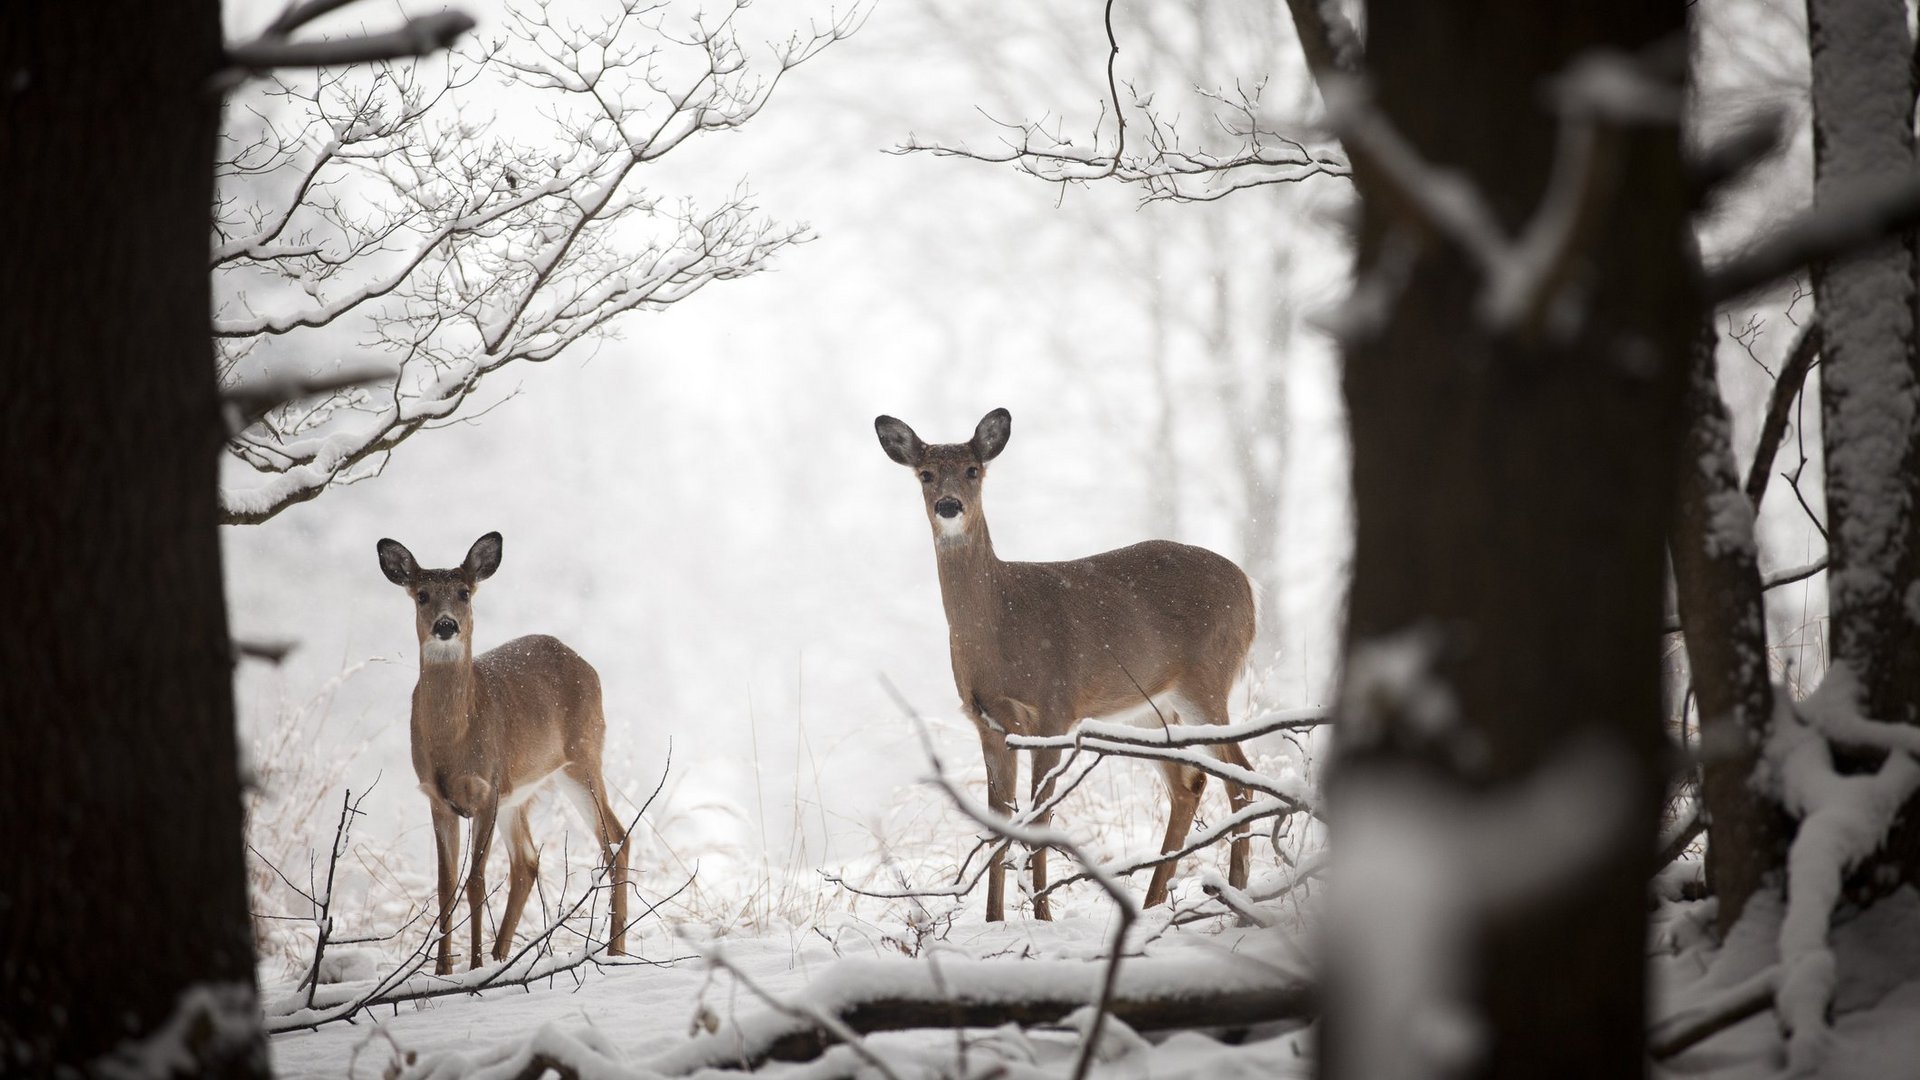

left=209, top=0, right=866, bottom=525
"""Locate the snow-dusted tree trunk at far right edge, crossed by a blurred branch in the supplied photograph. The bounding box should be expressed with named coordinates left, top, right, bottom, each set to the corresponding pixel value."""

left=1807, top=0, right=1920, bottom=721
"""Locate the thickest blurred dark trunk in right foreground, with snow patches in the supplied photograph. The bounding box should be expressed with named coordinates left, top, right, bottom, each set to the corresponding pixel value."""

left=1323, top=0, right=1699, bottom=1078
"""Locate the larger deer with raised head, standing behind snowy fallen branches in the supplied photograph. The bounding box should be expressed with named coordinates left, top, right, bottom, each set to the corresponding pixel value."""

left=874, top=409, right=1254, bottom=922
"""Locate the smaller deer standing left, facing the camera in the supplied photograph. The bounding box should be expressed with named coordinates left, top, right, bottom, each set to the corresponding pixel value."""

left=378, top=532, right=628, bottom=974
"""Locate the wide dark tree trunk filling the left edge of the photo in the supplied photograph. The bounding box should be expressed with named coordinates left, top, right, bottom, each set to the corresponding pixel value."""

left=0, top=0, right=267, bottom=1076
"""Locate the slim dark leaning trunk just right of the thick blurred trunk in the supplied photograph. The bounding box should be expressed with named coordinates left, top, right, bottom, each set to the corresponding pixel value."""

left=1670, top=323, right=1788, bottom=932
